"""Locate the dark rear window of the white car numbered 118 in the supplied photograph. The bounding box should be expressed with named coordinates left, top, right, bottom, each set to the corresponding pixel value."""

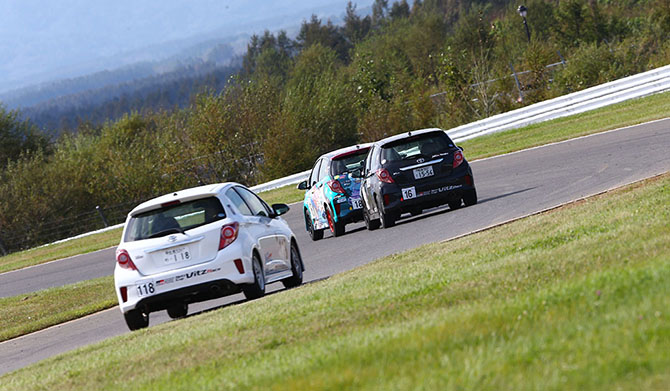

left=125, top=197, right=226, bottom=242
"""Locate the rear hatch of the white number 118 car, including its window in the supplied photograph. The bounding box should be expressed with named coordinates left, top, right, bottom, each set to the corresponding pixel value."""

left=120, top=196, right=226, bottom=275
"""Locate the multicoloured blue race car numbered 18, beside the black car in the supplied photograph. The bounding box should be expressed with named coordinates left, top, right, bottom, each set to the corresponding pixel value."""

left=298, top=144, right=372, bottom=240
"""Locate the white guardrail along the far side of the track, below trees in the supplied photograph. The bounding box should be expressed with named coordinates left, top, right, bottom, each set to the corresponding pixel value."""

left=251, top=65, right=670, bottom=192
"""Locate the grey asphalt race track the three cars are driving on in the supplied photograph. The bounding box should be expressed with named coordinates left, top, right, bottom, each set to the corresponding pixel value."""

left=0, top=119, right=670, bottom=374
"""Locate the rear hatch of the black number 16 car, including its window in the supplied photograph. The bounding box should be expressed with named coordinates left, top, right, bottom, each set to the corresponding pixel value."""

left=382, top=131, right=459, bottom=190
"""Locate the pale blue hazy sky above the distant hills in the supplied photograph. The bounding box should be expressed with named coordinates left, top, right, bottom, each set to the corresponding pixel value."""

left=0, top=0, right=372, bottom=91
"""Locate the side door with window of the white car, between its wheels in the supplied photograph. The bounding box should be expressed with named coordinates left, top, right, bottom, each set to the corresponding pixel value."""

left=235, top=186, right=291, bottom=282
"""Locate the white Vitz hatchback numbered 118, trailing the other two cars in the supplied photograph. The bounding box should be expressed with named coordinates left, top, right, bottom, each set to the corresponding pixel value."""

left=114, top=183, right=304, bottom=330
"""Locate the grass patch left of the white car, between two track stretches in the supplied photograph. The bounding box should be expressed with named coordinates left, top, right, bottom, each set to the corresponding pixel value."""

left=0, top=276, right=117, bottom=342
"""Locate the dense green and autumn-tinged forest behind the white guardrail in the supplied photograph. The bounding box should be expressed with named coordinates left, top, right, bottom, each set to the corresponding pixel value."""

left=0, top=0, right=670, bottom=251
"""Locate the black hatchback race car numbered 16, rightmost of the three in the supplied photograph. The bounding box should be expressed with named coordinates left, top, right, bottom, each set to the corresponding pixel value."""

left=361, top=129, right=477, bottom=230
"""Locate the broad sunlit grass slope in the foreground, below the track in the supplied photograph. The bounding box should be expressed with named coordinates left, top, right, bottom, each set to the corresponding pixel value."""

left=0, top=175, right=670, bottom=391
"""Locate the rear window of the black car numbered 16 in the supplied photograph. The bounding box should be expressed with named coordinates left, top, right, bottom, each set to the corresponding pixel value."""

left=382, top=132, right=454, bottom=164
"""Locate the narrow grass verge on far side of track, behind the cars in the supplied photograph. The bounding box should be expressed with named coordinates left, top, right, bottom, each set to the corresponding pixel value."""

left=0, top=93, right=670, bottom=273
